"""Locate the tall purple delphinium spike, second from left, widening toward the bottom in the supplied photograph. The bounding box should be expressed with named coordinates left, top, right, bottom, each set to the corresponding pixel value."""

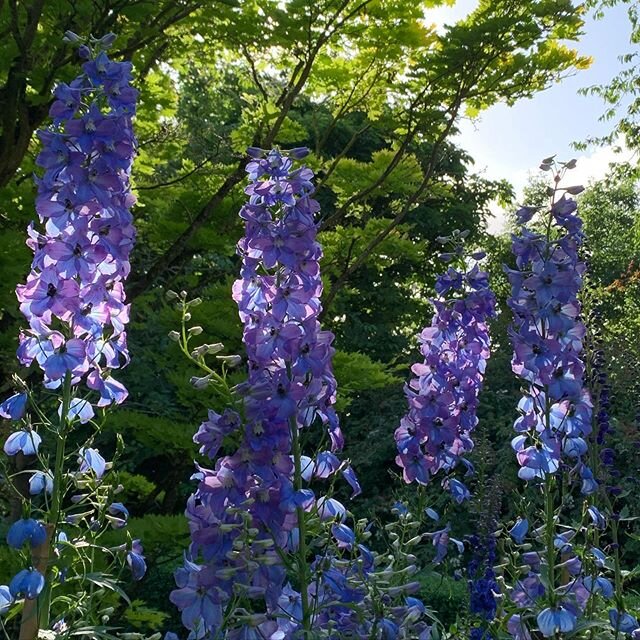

left=172, top=149, right=344, bottom=633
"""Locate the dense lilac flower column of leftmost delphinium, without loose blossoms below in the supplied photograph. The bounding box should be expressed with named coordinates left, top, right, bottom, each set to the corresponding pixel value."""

left=9, top=52, right=137, bottom=406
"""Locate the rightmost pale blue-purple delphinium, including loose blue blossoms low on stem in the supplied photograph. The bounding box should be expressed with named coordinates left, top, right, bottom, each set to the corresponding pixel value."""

left=506, top=181, right=613, bottom=640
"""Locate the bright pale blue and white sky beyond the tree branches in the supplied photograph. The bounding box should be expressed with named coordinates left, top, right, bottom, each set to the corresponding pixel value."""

left=427, top=0, right=634, bottom=233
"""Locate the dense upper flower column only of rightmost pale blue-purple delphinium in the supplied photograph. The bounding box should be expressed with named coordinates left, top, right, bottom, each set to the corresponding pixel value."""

left=507, top=195, right=598, bottom=494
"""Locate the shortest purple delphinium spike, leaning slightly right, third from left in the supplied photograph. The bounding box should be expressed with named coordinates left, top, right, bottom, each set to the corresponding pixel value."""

left=395, top=232, right=495, bottom=503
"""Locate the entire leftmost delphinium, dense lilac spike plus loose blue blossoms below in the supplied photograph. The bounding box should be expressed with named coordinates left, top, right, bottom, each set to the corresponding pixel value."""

left=0, top=38, right=145, bottom=637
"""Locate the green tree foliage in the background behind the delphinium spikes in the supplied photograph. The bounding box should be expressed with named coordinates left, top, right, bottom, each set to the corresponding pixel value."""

left=0, top=0, right=640, bottom=635
